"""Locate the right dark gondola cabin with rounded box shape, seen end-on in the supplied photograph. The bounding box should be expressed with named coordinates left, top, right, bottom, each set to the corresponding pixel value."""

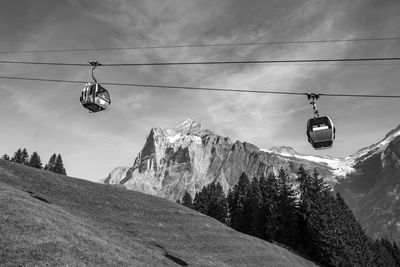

left=307, top=116, right=336, bottom=149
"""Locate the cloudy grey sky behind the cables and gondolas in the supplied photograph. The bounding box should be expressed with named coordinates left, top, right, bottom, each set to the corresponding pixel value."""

left=0, top=0, right=400, bottom=181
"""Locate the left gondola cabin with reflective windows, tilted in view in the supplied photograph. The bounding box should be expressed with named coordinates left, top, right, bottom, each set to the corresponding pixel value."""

left=80, top=82, right=111, bottom=112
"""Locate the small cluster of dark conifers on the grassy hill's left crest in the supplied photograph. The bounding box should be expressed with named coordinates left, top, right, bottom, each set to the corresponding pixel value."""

left=1, top=148, right=67, bottom=175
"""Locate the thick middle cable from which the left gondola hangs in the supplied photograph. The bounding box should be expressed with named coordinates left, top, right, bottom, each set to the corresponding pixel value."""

left=0, top=57, right=400, bottom=67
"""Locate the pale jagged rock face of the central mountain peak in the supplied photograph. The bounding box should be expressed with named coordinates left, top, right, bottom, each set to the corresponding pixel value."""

left=106, top=120, right=333, bottom=200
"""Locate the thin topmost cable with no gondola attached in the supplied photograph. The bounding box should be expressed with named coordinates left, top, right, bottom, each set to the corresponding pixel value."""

left=0, top=37, right=400, bottom=54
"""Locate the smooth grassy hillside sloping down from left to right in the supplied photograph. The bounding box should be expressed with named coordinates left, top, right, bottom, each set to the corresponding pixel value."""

left=0, top=160, right=314, bottom=266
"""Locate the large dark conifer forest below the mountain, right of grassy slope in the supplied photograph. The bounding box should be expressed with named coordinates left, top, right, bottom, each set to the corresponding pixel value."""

left=178, top=167, right=400, bottom=267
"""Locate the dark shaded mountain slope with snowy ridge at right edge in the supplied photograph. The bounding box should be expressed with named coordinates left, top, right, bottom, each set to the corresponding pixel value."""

left=335, top=128, right=400, bottom=246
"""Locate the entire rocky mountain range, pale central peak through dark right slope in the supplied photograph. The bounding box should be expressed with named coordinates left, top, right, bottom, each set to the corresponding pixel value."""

left=105, top=119, right=400, bottom=245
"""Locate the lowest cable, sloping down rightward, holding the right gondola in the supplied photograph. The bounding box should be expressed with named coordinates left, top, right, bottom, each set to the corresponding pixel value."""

left=0, top=76, right=400, bottom=98
